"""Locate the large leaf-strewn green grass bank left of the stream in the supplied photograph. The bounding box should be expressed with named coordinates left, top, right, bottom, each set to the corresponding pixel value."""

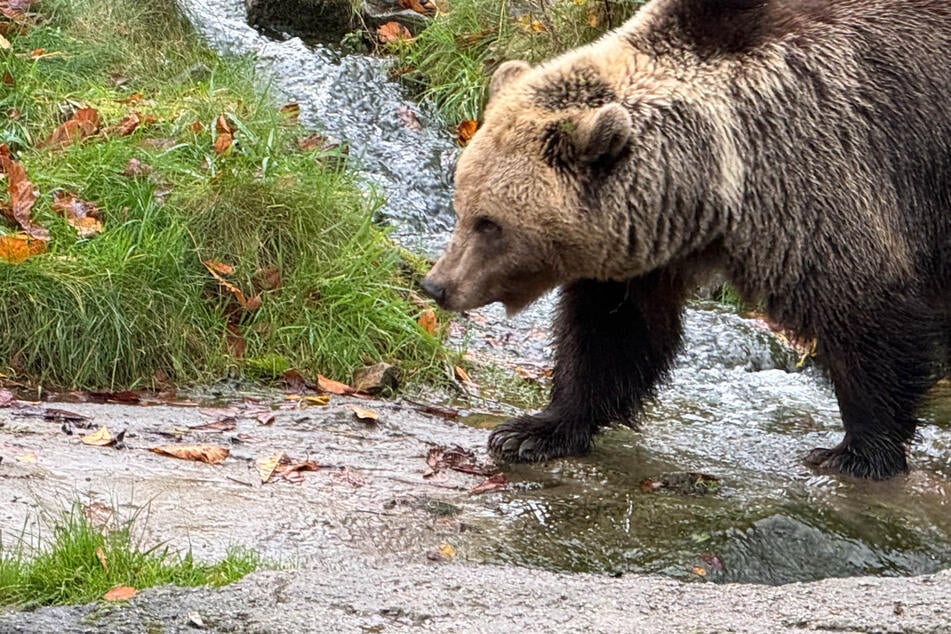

left=0, top=0, right=443, bottom=389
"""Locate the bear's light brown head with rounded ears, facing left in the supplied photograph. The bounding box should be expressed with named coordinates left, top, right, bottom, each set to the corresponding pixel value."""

left=423, top=62, right=632, bottom=314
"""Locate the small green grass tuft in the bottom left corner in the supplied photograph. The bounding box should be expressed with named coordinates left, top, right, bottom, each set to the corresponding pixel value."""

left=0, top=505, right=263, bottom=609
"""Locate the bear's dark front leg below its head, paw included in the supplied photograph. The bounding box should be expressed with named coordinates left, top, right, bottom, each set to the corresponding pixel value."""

left=489, top=271, right=686, bottom=462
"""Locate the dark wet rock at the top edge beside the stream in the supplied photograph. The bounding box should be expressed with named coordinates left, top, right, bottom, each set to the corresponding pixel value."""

left=245, top=0, right=356, bottom=42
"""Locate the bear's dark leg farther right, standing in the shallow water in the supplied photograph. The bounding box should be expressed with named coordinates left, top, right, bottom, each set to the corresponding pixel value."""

left=806, top=310, right=937, bottom=480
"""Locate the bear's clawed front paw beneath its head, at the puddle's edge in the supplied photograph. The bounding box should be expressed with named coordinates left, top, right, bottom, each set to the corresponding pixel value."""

left=489, top=416, right=591, bottom=462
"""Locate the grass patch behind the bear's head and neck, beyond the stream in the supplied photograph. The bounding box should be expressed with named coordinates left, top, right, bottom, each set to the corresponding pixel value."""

left=399, top=0, right=643, bottom=123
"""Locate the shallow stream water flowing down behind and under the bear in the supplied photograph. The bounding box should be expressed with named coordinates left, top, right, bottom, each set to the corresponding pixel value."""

left=173, top=0, right=951, bottom=583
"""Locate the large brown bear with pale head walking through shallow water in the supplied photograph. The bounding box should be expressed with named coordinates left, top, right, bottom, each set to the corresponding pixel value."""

left=423, top=0, right=951, bottom=479
